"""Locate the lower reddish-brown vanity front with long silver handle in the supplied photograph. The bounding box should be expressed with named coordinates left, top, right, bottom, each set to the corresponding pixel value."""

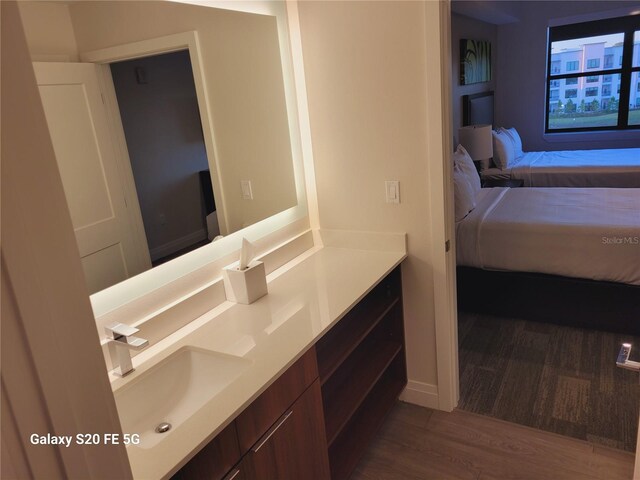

left=240, top=380, right=330, bottom=480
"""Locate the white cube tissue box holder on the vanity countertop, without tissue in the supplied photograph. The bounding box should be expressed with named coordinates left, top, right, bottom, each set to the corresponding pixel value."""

left=222, top=261, right=268, bottom=305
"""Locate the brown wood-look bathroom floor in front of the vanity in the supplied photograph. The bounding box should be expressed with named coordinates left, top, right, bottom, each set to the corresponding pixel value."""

left=351, top=402, right=634, bottom=480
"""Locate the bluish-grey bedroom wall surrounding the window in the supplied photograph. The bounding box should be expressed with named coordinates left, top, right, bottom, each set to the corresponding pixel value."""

left=495, top=1, right=640, bottom=151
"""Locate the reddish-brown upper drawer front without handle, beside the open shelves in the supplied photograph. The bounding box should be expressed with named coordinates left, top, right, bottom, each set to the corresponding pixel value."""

left=236, top=347, right=318, bottom=454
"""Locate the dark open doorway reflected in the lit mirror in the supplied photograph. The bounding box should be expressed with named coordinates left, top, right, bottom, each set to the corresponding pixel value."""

left=110, top=50, right=220, bottom=266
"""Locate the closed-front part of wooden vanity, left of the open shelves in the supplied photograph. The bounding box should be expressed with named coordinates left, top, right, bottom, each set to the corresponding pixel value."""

left=173, top=347, right=329, bottom=480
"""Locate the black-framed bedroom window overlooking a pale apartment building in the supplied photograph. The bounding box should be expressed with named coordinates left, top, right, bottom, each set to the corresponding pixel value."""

left=545, top=15, right=640, bottom=133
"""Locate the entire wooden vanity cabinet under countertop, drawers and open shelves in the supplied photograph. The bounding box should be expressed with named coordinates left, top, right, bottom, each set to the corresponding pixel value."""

left=174, top=267, right=407, bottom=480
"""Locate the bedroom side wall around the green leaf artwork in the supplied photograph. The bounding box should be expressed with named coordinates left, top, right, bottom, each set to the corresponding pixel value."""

left=451, top=13, right=498, bottom=146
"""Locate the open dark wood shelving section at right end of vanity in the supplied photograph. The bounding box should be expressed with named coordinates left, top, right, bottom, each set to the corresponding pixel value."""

left=316, top=267, right=407, bottom=480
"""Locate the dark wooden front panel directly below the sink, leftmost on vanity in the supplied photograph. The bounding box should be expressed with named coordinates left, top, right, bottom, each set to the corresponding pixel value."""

left=172, top=422, right=241, bottom=480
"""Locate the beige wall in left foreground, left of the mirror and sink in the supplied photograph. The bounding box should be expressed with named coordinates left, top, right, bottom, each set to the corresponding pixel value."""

left=0, top=2, right=131, bottom=480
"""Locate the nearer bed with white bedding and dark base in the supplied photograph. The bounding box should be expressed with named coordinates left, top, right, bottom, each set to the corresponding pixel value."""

left=456, top=184, right=640, bottom=335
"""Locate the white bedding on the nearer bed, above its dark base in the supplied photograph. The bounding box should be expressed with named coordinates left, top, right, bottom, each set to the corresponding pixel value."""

left=456, top=188, right=640, bottom=284
